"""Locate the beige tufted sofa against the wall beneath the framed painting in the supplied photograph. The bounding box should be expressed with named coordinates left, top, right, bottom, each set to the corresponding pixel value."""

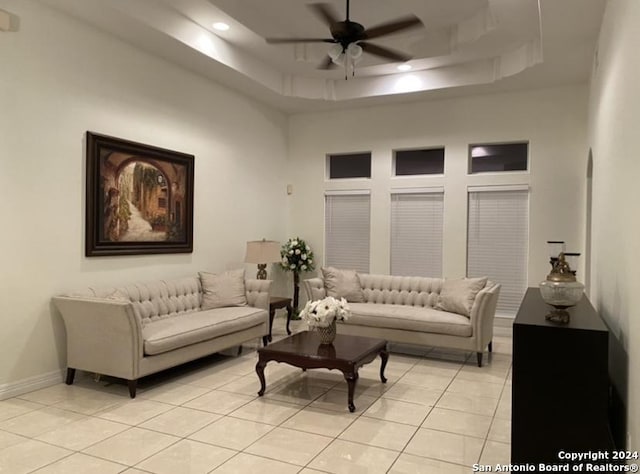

left=53, top=275, right=271, bottom=398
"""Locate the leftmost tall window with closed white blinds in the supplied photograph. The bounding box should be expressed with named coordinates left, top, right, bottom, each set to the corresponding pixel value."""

left=324, top=191, right=370, bottom=273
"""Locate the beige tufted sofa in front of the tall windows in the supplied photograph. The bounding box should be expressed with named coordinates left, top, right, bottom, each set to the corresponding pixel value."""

left=303, top=273, right=500, bottom=367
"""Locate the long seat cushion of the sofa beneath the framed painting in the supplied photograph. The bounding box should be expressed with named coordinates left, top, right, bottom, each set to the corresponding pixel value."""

left=142, top=306, right=269, bottom=355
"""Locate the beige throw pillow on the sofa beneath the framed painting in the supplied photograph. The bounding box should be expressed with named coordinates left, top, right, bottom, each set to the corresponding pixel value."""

left=199, top=269, right=247, bottom=309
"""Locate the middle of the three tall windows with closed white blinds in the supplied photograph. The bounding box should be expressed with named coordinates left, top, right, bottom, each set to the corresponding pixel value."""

left=391, top=189, right=444, bottom=278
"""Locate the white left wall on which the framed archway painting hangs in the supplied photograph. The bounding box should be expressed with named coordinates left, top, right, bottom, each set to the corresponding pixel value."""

left=0, top=0, right=287, bottom=395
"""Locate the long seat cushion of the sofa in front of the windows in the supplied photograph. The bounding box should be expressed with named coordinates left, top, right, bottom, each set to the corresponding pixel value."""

left=342, top=303, right=472, bottom=337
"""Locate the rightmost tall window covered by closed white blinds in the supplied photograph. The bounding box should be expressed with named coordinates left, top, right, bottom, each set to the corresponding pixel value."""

left=467, top=187, right=529, bottom=316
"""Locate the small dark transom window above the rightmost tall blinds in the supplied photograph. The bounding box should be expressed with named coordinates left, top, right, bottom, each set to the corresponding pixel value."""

left=469, top=143, right=529, bottom=174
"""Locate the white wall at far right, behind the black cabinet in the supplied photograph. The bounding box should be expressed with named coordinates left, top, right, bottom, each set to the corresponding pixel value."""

left=589, top=0, right=640, bottom=450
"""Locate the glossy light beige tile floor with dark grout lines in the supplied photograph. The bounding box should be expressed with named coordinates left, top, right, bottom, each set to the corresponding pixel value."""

left=0, top=317, right=511, bottom=474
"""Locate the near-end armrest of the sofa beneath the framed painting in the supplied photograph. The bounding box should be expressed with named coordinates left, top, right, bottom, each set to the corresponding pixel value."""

left=53, top=296, right=143, bottom=380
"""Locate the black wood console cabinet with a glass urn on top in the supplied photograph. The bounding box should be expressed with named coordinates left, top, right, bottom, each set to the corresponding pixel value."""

left=511, top=288, right=614, bottom=464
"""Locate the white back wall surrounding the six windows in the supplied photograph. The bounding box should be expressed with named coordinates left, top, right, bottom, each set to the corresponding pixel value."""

left=289, top=86, right=587, bottom=298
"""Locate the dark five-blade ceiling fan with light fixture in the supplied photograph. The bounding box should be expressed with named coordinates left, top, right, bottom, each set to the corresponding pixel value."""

left=266, top=0, right=423, bottom=73
